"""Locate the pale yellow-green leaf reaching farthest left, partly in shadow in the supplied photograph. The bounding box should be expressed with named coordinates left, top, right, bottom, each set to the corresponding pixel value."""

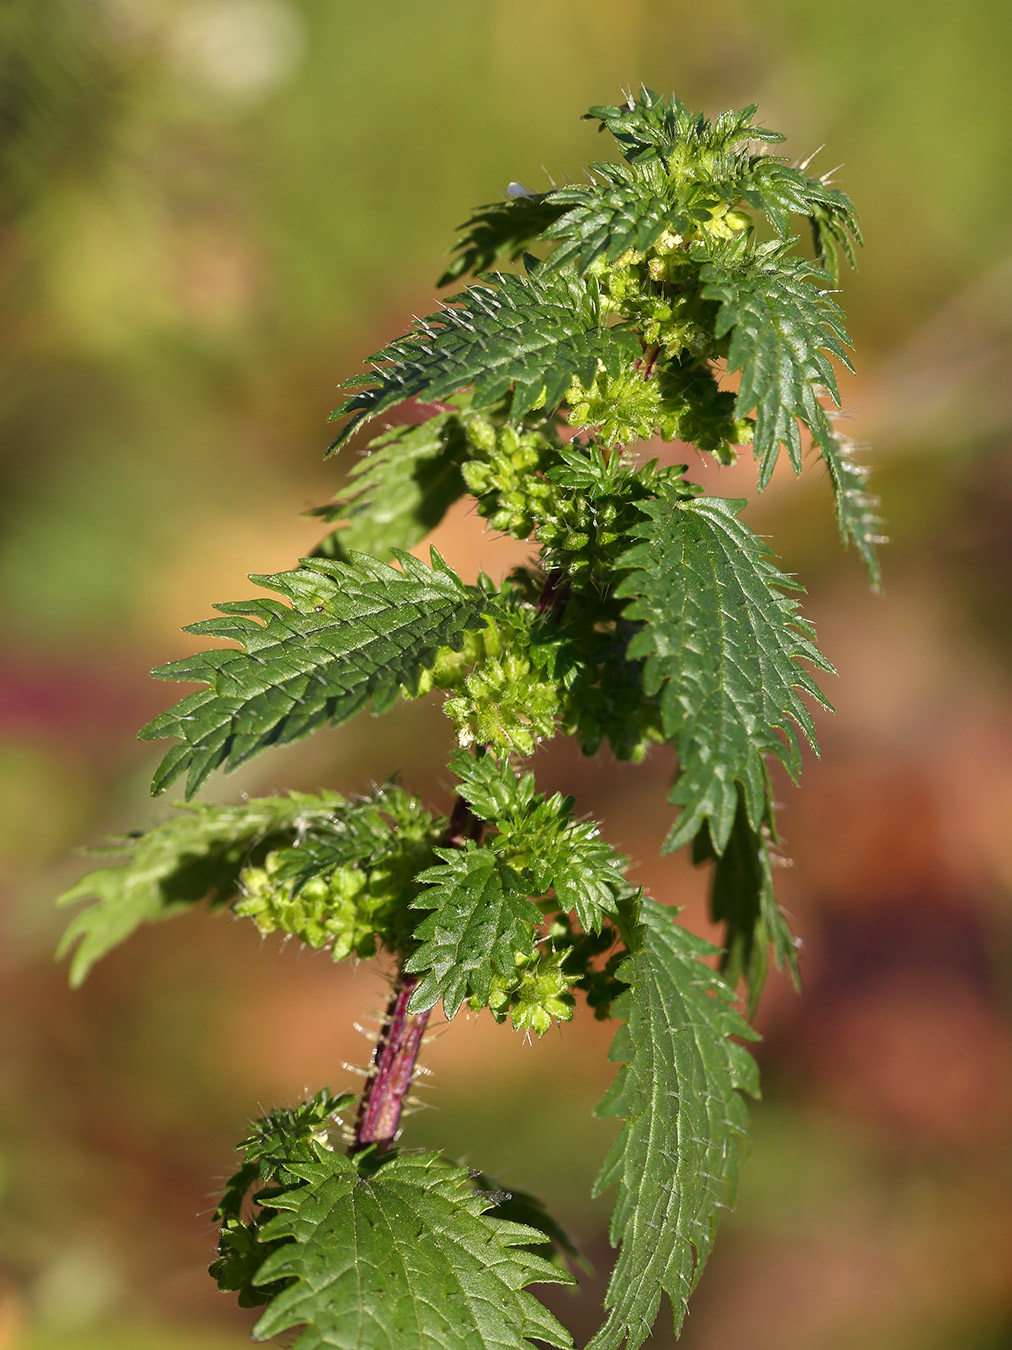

left=57, top=792, right=344, bottom=987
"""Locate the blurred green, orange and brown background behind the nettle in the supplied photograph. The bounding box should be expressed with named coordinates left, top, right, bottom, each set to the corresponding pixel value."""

left=0, top=0, right=1012, bottom=1350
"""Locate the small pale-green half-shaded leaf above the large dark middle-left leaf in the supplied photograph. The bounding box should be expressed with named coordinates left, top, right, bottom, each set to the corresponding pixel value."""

left=313, top=413, right=468, bottom=562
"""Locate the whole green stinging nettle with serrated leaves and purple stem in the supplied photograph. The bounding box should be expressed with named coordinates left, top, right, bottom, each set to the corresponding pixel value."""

left=62, top=90, right=878, bottom=1350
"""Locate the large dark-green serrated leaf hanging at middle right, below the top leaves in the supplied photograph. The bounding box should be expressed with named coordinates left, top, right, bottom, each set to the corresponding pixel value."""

left=617, top=486, right=833, bottom=853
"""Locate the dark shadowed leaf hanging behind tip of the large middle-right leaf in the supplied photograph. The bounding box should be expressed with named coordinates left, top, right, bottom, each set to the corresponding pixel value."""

left=692, top=801, right=800, bottom=1018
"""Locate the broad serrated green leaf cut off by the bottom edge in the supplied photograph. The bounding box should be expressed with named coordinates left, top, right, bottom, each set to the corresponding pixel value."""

left=254, top=1153, right=572, bottom=1350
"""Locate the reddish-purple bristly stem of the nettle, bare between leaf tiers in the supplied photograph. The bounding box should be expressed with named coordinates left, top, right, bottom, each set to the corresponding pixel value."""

left=348, top=797, right=482, bottom=1153
